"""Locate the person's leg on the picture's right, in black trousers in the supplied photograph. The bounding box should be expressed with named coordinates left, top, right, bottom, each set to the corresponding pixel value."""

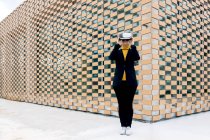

left=127, top=87, right=137, bottom=127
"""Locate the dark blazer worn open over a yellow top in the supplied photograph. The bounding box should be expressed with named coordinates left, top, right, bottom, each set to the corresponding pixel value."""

left=109, top=44, right=140, bottom=88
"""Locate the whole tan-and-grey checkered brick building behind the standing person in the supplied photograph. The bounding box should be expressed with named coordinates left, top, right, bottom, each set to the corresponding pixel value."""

left=0, top=0, right=210, bottom=122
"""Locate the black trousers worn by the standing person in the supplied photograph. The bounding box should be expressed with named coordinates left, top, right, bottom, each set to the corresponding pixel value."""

left=114, top=81, right=136, bottom=127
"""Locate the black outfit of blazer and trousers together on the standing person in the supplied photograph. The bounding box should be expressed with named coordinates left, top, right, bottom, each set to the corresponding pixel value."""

left=109, top=44, right=140, bottom=127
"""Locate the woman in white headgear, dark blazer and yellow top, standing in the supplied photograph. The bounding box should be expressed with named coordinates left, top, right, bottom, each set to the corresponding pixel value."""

left=109, top=32, right=140, bottom=135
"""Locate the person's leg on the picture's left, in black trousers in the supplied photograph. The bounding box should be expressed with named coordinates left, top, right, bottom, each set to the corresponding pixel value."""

left=114, top=82, right=127, bottom=127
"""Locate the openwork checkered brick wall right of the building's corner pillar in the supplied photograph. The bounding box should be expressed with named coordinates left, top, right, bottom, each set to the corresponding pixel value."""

left=159, top=0, right=210, bottom=119
